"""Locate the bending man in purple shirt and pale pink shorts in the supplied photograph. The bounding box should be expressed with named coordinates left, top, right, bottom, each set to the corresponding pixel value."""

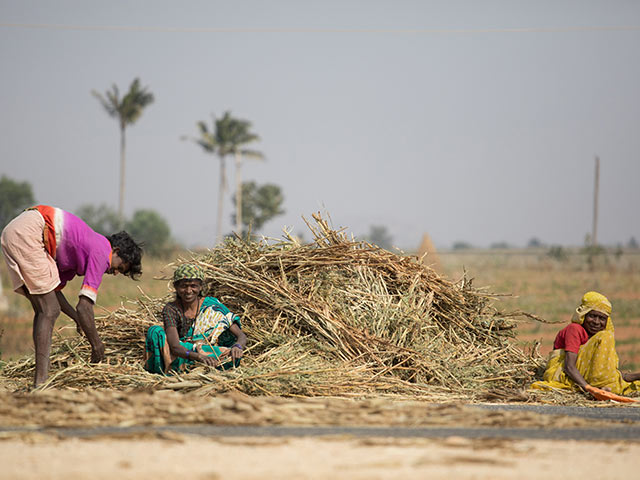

left=1, top=205, right=142, bottom=387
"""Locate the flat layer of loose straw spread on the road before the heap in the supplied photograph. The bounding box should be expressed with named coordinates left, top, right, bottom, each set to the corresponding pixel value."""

left=0, top=389, right=611, bottom=430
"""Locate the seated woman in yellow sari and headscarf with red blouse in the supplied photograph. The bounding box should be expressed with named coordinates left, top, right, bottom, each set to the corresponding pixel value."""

left=531, top=292, right=640, bottom=398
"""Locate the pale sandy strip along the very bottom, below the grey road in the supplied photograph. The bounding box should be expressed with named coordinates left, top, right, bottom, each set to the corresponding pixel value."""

left=0, top=434, right=640, bottom=480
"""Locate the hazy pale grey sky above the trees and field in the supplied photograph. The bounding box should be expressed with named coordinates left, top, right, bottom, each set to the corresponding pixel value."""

left=0, top=0, right=640, bottom=249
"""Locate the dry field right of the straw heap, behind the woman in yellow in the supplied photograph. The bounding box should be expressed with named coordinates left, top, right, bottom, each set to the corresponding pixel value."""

left=439, top=249, right=640, bottom=371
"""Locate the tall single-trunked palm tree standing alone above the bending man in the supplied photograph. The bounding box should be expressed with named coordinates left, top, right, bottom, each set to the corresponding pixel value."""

left=91, top=78, right=153, bottom=228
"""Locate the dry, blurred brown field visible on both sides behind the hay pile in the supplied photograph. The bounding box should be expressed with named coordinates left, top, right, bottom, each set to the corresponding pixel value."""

left=0, top=249, right=640, bottom=371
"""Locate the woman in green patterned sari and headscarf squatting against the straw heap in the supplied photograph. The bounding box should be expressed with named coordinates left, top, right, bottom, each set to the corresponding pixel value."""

left=145, top=263, right=247, bottom=374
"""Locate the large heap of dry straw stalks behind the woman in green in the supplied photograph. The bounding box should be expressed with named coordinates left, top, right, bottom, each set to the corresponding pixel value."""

left=2, top=215, right=540, bottom=398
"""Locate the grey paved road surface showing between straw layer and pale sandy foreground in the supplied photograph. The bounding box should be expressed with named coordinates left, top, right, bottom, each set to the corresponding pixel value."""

left=5, top=405, right=640, bottom=441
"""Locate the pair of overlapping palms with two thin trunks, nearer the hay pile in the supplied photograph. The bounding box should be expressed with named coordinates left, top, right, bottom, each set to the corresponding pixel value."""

left=185, top=111, right=263, bottom=243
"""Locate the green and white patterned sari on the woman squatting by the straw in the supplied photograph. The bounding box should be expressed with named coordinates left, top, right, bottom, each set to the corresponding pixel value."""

left=144, top=297, right=241, bottom=375
